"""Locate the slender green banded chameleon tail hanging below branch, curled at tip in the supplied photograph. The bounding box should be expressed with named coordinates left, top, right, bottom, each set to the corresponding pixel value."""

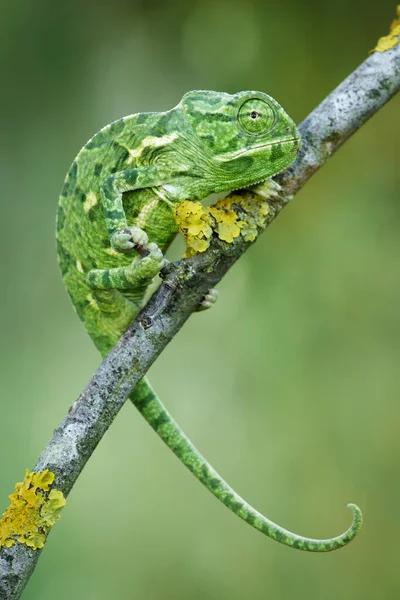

left=130, top=379, right=362, bottom=552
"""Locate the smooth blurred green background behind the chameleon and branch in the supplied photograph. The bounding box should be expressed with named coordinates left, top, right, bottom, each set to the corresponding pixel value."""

left=0, top=0, right=400, bottom=600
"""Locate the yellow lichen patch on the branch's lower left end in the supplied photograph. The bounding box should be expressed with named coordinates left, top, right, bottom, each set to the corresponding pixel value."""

left=0, top=469, right=66, bottom=550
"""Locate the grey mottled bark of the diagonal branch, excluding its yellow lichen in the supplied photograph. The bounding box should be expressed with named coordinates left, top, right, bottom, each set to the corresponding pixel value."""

left=0, top=36, right=400, bottom=599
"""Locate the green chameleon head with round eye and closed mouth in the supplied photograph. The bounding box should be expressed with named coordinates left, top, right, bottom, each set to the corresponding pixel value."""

left=182, top=91, right=300, bottom=192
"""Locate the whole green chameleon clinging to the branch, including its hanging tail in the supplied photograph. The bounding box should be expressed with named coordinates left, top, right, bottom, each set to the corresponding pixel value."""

left=57, top=91, right=361, bottom=552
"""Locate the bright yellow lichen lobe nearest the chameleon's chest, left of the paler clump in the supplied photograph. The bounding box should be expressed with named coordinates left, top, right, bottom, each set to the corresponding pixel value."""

left=174, top=200, right=212, bottom=256
